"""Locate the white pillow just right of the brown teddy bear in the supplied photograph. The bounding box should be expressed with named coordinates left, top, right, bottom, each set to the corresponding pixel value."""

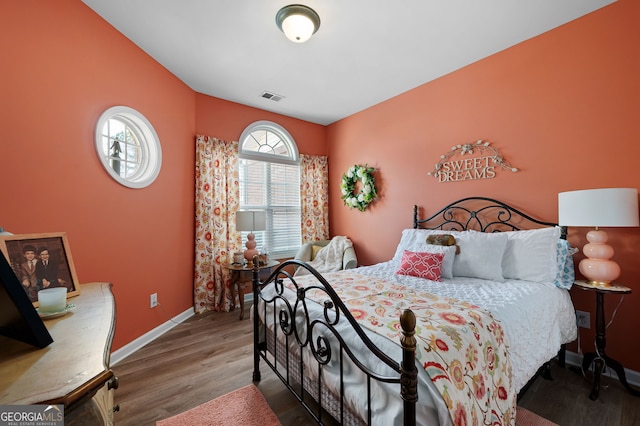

left=453, top=231, right=507, bottom=282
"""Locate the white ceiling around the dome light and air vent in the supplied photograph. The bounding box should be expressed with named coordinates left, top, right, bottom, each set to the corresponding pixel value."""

left=82, top=0, right=615, bottom=125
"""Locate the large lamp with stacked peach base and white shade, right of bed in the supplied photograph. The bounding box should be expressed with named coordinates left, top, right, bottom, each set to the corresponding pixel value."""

left=558, top=188, right=639, bottom=287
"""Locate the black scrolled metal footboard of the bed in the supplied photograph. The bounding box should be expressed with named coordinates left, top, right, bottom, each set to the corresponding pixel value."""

left=253, top=260, right=418, bottom=426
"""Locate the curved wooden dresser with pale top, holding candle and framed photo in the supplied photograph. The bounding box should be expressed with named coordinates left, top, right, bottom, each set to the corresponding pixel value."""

left=0, top=283, right=118, bottom=425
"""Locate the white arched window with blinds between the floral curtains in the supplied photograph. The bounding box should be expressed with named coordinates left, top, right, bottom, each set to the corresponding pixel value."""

left=239, top=121, right=302, bottom=258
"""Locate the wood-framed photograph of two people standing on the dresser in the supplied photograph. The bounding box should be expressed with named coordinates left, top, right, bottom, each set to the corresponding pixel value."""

left=0, top=232, right=80, bottom=307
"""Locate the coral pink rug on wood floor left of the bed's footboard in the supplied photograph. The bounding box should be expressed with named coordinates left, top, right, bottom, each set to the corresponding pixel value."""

left=156, top=384, right=282, bottom=426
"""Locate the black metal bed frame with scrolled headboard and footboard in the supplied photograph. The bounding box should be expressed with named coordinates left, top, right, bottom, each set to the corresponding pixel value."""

left=253, top=197, right=566, bottom=426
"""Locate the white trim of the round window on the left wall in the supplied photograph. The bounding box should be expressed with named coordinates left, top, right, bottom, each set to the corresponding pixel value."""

left=94, top=105, right=162, bottom=189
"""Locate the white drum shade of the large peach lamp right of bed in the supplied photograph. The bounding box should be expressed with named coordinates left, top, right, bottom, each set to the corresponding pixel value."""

left=558, top=188, right=639, bottom=227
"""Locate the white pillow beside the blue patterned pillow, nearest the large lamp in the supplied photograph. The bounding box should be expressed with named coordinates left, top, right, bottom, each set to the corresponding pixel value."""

left=502, top=226, right=561, bottom=283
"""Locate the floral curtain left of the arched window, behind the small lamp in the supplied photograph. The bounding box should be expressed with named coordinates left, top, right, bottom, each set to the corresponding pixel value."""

left=194, top=135, right=242, bottom=313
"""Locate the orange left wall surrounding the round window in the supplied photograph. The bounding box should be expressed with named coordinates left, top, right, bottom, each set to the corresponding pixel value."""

left=0, top=0, right=195, bottom=349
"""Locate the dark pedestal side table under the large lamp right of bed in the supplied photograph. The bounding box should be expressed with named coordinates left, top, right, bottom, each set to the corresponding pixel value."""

left=575, top=281, right=640, bottom=400
